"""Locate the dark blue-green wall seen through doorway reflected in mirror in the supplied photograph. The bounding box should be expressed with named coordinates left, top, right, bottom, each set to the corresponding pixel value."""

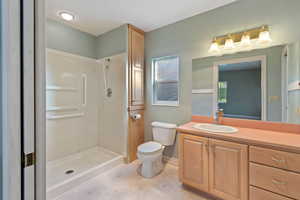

left=219, top=68, right=261, bottom=119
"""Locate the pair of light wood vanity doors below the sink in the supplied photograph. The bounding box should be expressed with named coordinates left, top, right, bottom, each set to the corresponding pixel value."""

left=179, top=134, right=248, bottom=200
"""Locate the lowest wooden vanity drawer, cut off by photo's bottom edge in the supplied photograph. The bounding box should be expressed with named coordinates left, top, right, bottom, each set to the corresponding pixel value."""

left=249, top=186, right=292, bottom=200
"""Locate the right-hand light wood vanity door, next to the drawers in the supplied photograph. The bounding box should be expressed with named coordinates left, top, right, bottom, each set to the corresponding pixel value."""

left=209, top=139, right=248, bottom=200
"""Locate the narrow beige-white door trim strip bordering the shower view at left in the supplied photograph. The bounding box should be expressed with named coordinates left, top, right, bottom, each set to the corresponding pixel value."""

left=35, top=0, right=46, bottom=200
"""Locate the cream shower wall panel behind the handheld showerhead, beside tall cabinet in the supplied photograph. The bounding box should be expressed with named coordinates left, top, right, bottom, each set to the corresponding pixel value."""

left=99, top=53, right=128, bottom=156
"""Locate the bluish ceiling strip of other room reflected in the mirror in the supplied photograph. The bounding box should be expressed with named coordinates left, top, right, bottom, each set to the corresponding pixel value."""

left=219, top=61, right=261, bottom=72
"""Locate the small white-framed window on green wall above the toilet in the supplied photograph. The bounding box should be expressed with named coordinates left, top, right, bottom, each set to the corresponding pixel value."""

left=152, top=56, right=179, bottom=106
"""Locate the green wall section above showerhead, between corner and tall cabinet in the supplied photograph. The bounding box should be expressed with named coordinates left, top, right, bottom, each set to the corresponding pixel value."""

left=96, top=25, right=128, bottom=59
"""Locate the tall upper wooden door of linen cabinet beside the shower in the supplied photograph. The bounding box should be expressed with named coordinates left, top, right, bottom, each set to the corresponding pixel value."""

left=129, top=26, right=144, bottom=107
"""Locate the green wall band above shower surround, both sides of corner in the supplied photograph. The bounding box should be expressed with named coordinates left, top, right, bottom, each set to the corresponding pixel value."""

left=46, top=19, right=128, bottom=59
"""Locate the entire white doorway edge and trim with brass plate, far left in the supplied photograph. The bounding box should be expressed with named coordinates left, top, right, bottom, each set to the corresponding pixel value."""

left=0, top=0, right=46, bottom=200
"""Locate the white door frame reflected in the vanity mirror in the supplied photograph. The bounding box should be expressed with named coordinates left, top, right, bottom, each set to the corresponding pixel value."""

left=212, top=55, right=267, bottom=121
